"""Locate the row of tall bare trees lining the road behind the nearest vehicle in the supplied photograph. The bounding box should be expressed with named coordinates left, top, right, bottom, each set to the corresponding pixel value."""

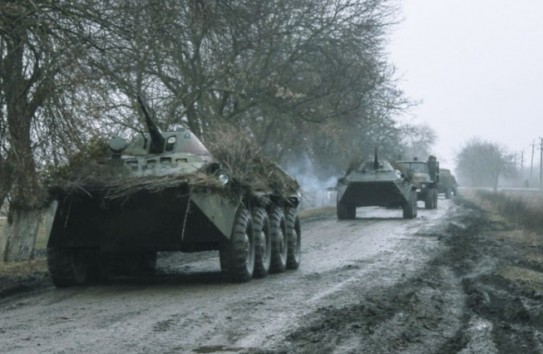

left=0, top=0, right=435, bottom=259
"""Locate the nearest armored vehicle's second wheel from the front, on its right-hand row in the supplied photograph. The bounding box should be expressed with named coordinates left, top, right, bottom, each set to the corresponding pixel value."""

left=252, top=208, right=271, bottom=278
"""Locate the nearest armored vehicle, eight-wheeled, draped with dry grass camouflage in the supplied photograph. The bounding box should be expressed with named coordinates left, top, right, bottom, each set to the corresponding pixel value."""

left=47, top=101, right=301, bottom=287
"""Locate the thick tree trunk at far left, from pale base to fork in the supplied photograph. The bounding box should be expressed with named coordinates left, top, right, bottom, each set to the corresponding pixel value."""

left=0, top=20, right=50, bottom=261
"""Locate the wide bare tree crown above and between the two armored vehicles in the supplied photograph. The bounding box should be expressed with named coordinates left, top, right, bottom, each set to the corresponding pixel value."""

left=115, top=0, right=406, bottom=166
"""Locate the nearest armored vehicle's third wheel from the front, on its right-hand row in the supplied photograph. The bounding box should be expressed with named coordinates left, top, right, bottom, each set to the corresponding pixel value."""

left=269, top=206, right=288, bottom=273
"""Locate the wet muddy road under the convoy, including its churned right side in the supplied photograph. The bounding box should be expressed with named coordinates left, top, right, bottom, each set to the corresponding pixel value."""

left=0, top=199, right=543, bottom=353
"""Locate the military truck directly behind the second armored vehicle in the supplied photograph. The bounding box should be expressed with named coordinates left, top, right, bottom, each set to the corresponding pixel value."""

left=396, top=156, right=439, bottom=209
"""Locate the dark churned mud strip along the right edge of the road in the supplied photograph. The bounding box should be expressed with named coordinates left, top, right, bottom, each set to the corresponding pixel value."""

left=252, top=200, right=543, bottom=353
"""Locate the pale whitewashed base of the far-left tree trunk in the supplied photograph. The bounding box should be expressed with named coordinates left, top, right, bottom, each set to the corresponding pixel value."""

left=0, top=208, right=42, bottom=262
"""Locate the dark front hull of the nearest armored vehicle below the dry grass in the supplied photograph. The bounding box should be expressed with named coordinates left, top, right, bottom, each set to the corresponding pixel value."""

left=48, top=186, right=239, bottom=252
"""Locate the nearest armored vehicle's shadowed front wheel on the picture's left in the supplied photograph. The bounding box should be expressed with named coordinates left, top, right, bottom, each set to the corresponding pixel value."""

left=47, top=248, right=89, bottom=288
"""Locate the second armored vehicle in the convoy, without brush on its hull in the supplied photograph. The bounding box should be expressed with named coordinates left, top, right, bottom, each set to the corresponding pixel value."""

left=337, top=153, right=417, bottom=220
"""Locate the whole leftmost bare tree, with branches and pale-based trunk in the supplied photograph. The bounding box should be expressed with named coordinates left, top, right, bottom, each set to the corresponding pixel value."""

left=0, top=0, right=110, bottom=260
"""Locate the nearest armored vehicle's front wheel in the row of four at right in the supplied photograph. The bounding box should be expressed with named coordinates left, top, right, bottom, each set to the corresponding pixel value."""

left=219, top=208, right=255, bottom=282
